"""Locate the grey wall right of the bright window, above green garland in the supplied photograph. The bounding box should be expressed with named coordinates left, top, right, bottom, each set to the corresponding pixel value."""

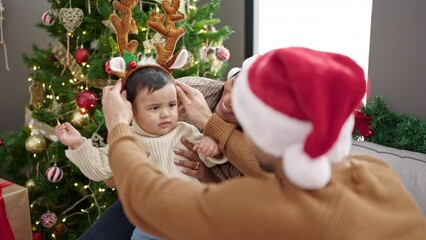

left=369, top=0, right=426, bottom=120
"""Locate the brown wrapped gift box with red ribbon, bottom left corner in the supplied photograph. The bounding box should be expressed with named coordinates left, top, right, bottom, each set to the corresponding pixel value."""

left=0, top=178, right=32, bottom=240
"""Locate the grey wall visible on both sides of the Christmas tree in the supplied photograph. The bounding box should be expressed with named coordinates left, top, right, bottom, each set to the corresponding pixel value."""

left=0, top=0, right=244, bottom=133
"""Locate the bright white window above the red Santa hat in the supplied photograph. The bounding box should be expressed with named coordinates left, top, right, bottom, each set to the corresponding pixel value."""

left=253, top=0, right=373, bottom=74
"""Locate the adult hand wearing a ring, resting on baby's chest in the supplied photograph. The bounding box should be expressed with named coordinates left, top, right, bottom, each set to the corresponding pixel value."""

left=173, top=139, right=220, bottom=183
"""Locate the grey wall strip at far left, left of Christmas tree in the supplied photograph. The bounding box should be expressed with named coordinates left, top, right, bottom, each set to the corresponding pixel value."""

left=0, top=0, right=49, bottom=133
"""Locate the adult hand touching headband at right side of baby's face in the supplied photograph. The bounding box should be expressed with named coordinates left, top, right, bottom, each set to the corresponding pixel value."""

left=176, top=81, right=212, bottom=129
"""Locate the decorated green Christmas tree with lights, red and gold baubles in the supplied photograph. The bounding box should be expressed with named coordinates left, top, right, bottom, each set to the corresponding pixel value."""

left=0, top=0, right=231, bottom=239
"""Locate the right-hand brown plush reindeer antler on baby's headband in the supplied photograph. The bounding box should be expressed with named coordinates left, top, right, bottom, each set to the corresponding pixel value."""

left=146, top=0, right=186, bottom=69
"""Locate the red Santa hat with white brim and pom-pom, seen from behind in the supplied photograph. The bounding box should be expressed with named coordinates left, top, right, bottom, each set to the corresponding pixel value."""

left=232, top=47, right=366, bottom=189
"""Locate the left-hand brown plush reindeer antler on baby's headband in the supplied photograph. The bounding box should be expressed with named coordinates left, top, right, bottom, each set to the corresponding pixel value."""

left=109, top=0, right=138, bottom=55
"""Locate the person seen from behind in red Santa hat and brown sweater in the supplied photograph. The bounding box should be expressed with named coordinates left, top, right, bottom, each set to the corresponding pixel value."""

left=102, top=48, right=426, bottom=240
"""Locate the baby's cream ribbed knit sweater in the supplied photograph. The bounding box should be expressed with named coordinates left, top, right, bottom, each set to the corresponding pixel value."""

left=65, top=122, right=228, bottom=181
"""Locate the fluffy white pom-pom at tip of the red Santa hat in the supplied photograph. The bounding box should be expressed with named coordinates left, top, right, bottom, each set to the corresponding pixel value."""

left=283, top=144, right=331, bottom=190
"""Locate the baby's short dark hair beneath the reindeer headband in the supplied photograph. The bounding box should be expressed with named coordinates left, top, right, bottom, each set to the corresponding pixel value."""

left=124, top=66, right=175, bottom=103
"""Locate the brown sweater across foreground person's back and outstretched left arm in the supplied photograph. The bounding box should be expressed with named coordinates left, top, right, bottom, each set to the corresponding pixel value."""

left=108, top=123, right=426, bottom=240
